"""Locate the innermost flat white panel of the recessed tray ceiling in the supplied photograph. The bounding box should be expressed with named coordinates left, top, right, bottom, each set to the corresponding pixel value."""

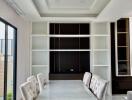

left=46, top=0, right=96, bottom=9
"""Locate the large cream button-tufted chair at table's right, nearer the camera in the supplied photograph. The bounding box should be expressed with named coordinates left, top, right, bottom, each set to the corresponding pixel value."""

left=90, top=75, right=108, bottom=100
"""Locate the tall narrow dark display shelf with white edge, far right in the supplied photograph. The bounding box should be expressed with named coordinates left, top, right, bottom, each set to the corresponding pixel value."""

left=115, top=18, right=131, bottom=76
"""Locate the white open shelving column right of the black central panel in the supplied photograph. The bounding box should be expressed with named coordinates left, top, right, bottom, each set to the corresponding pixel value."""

left=91, top=22, right=111, bottom=96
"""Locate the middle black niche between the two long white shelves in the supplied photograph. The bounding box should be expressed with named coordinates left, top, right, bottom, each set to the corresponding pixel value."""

left=50, top=37, right=90, bottom=49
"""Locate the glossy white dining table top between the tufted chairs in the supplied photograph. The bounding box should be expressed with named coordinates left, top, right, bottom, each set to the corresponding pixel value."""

left=37, top=80, right=97, bottom=100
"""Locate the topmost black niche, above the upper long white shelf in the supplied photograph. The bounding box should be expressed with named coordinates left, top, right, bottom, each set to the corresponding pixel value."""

left=49, top=23, right=90, bottom=35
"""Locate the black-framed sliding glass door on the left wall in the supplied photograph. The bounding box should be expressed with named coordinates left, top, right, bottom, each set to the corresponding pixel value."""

left=0, top=19, right=17, bottom=100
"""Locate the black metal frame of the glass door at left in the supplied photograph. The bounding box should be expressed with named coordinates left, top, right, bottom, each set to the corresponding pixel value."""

left=0, top=17, right=17, bottom=100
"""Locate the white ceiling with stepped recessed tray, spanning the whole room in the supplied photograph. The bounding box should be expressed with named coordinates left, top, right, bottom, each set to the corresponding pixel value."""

left=6, top=0, right=132, bottom=21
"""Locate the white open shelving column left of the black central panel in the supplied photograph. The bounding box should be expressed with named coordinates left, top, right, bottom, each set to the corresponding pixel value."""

left=31, top=22, right=49, bottom=79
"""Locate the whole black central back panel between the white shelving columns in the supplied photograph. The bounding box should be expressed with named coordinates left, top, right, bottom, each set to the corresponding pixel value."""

left=49, top=23, right=90, bottom=79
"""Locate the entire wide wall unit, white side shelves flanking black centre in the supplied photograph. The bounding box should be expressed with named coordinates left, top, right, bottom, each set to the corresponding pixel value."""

left=31, top=22, right=111, bottom=95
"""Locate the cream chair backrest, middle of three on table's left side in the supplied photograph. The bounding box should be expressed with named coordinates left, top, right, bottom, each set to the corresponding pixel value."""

left=27, top=76, right=40, bottom=97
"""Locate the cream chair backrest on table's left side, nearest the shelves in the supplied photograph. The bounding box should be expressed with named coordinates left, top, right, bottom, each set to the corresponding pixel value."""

left=37, top=73, right=47, bottom=92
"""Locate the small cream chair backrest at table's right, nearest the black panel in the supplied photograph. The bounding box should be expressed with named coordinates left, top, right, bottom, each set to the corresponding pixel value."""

left=83, top=72, right=92, bottom=88
